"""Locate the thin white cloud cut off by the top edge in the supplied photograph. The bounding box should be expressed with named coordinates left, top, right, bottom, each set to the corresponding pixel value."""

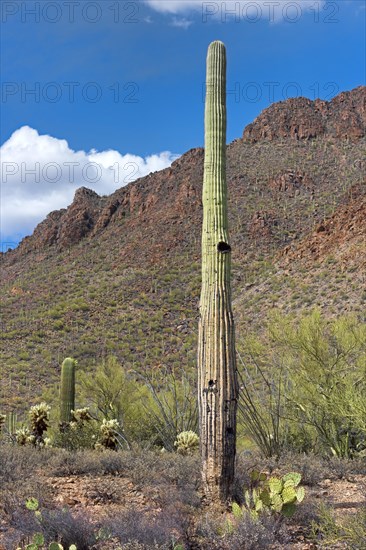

left=145, top=0, right=325, bottom=22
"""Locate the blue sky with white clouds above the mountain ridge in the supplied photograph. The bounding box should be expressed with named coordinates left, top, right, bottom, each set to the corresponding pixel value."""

left=1, top=0, right=366, bottom=247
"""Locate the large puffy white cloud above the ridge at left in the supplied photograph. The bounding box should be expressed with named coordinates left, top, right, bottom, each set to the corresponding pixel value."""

left=0, top=126, right=179, bottom=244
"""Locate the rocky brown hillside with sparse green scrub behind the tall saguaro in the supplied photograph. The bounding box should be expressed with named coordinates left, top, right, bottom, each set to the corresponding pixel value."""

left=0, top=87, right=366, bottom=414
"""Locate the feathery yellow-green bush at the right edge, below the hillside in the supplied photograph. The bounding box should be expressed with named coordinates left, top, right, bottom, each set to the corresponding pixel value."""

left=282, top=311, right=366, bottom=458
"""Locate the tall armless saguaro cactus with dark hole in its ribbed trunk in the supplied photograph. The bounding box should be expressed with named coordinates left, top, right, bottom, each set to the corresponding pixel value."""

left=198, top=41, right=238, bottom=502
